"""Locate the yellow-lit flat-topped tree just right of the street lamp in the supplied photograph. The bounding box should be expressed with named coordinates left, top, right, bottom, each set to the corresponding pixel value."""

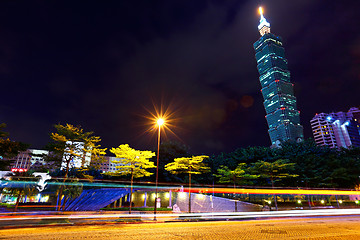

left=165, top=155, right=210, bottom=213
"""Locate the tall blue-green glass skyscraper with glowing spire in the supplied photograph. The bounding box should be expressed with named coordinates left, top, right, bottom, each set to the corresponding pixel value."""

left=254, top=8, right=304, bottom=147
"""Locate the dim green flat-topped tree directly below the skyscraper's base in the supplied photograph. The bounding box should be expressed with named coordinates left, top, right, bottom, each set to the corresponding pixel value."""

left=252, top=159, right=298, bottom=210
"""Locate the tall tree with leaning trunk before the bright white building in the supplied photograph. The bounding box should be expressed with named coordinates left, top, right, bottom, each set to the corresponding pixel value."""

left=49, top=124, right=106, bottom=210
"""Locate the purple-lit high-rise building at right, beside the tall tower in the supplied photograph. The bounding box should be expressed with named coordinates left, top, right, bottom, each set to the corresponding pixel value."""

left=310, top=108, right=360, bottom=148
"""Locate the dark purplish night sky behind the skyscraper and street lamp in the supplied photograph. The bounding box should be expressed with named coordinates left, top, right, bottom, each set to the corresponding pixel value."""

left=0, top=0, right=360, bottom=155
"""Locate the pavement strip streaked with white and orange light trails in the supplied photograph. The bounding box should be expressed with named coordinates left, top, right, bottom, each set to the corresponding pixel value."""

left=0, top=209, right=360, bottom=230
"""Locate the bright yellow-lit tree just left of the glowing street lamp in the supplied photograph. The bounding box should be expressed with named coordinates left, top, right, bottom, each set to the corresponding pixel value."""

left=110, top=144, right=156, bottom=214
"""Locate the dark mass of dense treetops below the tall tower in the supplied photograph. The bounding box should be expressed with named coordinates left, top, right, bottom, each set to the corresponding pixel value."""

left=204, top=139, right=360, bottom=188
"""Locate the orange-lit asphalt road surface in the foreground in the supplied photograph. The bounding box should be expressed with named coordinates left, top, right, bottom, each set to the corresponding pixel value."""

left=0, top=216, right=360, bottom=240
